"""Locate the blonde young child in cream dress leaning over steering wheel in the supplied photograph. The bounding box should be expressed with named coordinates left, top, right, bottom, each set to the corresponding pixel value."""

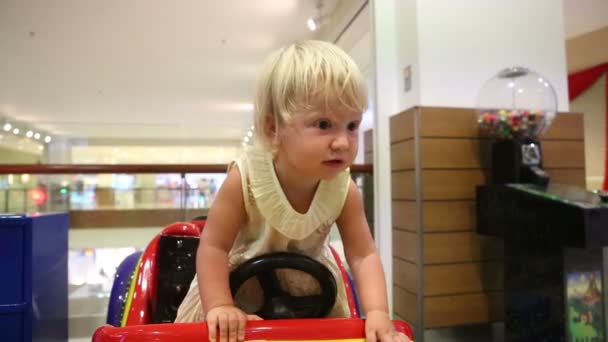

left=176, top=41, right=408, bottom=342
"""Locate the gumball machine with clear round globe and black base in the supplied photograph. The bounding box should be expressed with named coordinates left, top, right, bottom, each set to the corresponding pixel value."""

left=476, top=67, right=557, bottom=186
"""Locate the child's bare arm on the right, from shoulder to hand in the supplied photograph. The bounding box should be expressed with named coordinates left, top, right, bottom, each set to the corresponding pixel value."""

left=336, top=181, right=405, bottom=342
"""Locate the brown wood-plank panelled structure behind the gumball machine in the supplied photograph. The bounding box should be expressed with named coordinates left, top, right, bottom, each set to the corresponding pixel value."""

left=390, top=107, right=585, bottom=329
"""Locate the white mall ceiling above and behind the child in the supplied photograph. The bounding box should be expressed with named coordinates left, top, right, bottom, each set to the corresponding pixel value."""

left=0, top=0, right=608, bottom=141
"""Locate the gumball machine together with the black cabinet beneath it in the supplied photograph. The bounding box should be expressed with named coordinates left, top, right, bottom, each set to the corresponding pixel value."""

left=476, top=68, right=608, bottom=342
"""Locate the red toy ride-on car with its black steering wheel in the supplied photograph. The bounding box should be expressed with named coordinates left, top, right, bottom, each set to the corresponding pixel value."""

left=93, top=218, right=413, bottom=342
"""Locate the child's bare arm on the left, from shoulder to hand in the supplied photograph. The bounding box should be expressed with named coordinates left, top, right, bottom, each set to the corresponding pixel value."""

left=196, top=167, right=258, bottom=342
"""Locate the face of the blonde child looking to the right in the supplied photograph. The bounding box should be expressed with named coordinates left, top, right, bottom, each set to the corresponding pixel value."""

left=276, top=102, right=362, bottom=179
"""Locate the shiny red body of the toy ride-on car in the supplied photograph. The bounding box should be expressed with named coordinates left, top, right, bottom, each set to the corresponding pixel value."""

left=93, top=220, right=413, bottom=342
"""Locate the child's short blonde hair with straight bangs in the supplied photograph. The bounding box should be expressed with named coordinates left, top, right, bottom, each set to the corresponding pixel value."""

left=255, top=40, right=368, bottom=149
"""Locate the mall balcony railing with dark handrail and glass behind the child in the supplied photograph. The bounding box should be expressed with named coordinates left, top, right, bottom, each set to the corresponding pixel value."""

left=0, top=164, right=373, bottom=228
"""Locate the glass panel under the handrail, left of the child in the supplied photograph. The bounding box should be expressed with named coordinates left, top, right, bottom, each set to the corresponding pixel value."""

left=0, top=173, right=226, bottom=213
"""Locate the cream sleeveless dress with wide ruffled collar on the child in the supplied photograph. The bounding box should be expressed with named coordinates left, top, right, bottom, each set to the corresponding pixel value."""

left=175, top=147, right=350, bottom=322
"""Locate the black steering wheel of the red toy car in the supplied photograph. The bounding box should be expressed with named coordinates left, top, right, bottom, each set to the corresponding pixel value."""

left=230, top=252, right=337, bottom=319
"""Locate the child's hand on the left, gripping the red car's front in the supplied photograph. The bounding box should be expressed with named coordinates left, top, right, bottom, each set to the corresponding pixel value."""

left=205, top=305, right=261, bottom=342
